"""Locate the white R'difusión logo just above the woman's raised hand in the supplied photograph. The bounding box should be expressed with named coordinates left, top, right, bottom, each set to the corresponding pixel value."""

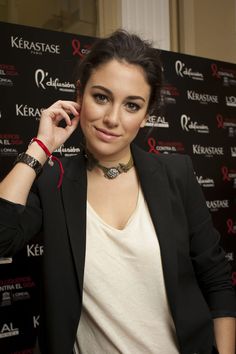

left=34, top=69, right=75, bottom=92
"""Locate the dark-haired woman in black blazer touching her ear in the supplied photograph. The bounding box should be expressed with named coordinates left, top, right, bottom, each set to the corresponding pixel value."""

left=0, top=31, right=236, bottom=354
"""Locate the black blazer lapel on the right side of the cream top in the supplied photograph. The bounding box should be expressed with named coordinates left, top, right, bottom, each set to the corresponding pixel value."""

left=132, top=146, right=177, bottom=316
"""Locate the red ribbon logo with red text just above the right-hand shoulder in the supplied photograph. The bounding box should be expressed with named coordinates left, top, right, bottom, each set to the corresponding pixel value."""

left=148, top=138, right=184, bottom=154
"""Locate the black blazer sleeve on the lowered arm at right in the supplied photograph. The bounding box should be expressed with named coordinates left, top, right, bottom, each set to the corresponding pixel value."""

left=185, top=156, right=236, bottom=318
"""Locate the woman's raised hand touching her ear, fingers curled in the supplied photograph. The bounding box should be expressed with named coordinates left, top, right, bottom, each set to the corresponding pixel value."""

left=37, top=101, right=80, bottom=153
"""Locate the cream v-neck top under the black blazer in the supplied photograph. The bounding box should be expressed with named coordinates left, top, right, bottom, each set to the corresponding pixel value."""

left=74, top=189, right=179, bottom=354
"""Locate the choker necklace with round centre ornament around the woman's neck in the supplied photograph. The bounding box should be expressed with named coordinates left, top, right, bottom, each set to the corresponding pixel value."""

left=85, top=149, right=134, bottom=179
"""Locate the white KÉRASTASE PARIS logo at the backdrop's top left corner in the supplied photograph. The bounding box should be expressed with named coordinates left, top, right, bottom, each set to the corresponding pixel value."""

left=11, top=36, right=60, bottom=55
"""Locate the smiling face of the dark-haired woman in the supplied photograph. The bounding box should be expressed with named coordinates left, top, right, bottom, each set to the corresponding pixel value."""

left=80, top=60, right=150, bottom=160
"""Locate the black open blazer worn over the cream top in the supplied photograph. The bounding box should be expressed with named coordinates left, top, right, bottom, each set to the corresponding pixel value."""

left=0, top=146, right=236, bottom=354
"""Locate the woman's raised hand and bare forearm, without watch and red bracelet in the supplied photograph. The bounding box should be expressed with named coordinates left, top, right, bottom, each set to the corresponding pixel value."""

left=0, top=101, right=80, bottom=205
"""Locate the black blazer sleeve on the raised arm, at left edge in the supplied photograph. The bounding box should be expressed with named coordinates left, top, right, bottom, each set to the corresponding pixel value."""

left=0, top=187, right=42, bottom=257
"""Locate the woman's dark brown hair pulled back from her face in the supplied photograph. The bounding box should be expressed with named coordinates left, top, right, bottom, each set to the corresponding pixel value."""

left=77, top=30, right=163, bottom=115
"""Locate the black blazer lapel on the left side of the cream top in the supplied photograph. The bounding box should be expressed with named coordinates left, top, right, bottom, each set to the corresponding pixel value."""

left=62, top=155, right=87, bottom=294
